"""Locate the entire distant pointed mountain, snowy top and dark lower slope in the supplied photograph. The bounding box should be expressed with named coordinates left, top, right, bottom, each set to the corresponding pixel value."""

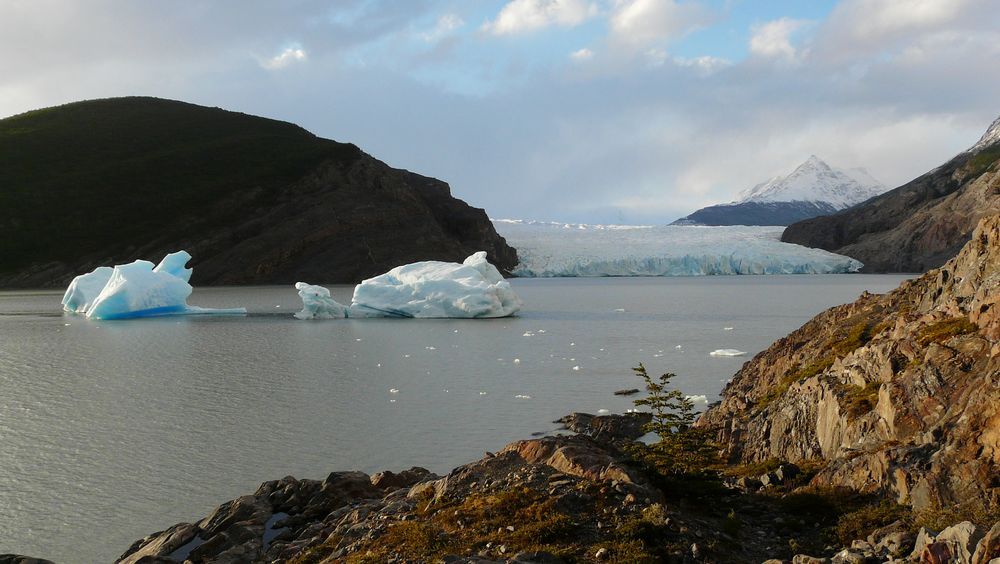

left=674, top=155, right=885, bottom=225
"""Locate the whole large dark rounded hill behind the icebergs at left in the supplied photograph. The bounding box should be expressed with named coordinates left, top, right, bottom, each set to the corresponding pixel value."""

left=0, top=98, right=517, bottom=287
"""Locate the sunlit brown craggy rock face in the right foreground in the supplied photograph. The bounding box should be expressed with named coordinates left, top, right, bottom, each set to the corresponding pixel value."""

left=699, top=216, right=1000, bottom=510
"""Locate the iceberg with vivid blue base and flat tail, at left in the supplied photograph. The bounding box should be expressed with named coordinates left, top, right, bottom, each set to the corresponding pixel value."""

left=62, top=251, right=246, bottom=320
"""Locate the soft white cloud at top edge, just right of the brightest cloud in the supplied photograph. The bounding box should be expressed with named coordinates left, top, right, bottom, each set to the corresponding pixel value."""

left=610, top=0, right=710, bottom=46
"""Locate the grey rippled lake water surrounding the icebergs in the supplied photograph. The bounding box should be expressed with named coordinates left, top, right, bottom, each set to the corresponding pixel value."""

left=0, top=275, right=906, bottom=563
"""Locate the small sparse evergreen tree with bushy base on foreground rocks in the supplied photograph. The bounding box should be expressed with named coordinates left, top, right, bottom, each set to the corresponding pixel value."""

left=630, top=363, right=719, bottom=475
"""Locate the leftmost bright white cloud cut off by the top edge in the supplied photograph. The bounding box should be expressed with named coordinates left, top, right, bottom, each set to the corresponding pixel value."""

left=482, top=0, right=598, bottom=35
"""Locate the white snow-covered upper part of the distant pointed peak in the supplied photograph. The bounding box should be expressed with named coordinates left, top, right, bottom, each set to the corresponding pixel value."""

left=733, top=155, right=888, bottom=210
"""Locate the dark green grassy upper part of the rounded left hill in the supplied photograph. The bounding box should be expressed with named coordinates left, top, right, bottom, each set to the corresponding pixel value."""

left=0, top=98, right=361, bottom=272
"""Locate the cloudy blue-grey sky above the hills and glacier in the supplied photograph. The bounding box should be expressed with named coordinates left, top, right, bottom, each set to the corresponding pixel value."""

left=0, top=0, right=1000, bottom=223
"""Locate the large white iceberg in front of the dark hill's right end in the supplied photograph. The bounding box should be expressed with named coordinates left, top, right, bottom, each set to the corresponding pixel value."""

left=349, top=251, right=521, bottom=318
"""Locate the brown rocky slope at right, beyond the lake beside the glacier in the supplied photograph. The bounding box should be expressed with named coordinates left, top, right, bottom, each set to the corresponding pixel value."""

left=781, top=119, right=1000, bottom=272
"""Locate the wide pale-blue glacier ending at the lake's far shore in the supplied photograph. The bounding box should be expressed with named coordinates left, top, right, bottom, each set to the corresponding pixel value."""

left=493, top=219, right=864, bottom=277
